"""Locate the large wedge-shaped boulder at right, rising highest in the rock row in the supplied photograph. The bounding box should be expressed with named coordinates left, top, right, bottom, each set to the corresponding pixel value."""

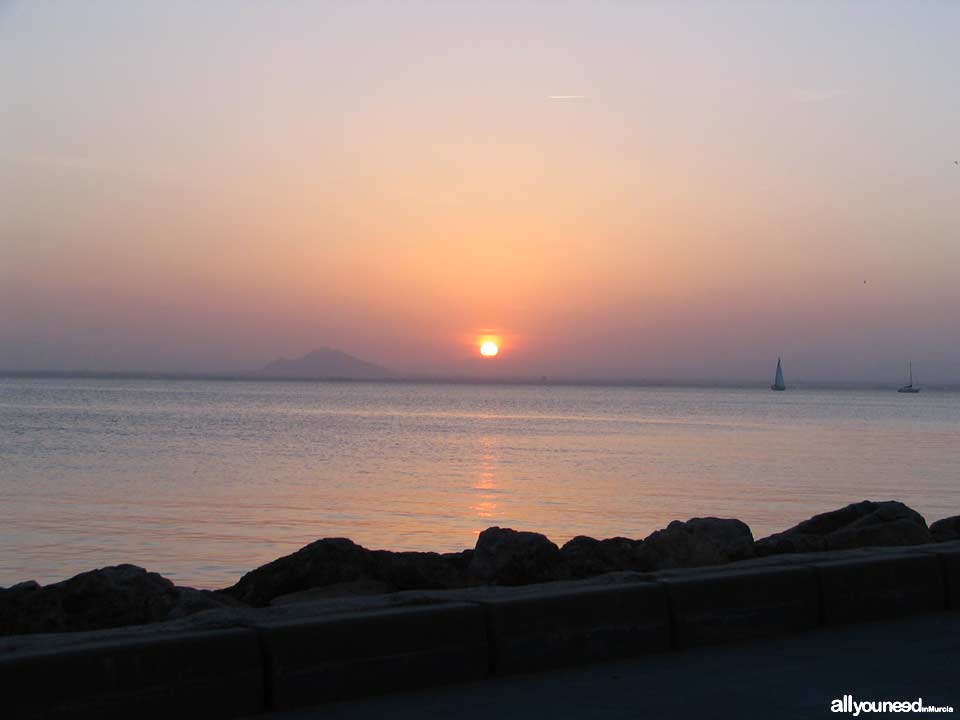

left=754, top=500, right=933, bottom=557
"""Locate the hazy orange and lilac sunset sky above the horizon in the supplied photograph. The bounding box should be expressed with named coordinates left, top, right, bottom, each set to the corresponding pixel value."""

left=0, top=0, right=960, bottom=382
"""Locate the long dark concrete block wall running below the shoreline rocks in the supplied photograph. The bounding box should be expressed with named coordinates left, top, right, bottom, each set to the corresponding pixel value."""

left=0, top=543, right=960, bottom=719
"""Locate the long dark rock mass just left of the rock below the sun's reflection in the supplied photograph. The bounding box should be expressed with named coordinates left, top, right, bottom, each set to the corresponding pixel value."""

left=220, top=538, right=471, bottom=607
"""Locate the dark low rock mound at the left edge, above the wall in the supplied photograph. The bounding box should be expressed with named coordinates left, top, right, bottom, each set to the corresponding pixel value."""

left=0, top=565, right=221, bottom=635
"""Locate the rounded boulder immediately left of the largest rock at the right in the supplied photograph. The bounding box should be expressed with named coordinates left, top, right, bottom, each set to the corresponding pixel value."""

left=635, top=517, right=753, bottom=571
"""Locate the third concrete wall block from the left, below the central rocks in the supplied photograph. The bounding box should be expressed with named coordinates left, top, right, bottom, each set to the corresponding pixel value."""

left=483, top=583, right=670, bottom=674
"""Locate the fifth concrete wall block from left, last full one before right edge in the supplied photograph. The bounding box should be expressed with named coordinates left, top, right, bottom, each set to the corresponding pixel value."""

left=815, top=551, right=946, bottom=625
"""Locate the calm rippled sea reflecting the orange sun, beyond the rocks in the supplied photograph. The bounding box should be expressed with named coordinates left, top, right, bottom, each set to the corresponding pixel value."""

left=0, top=379, right=960, bottom=587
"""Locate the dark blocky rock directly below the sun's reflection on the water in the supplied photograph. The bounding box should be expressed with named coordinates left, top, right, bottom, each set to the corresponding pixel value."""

left=467, top=527, right=565, bottom=585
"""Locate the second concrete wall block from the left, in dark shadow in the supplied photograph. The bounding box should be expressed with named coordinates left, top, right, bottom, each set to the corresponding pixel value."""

left=257, top=603, right=489, bottom=709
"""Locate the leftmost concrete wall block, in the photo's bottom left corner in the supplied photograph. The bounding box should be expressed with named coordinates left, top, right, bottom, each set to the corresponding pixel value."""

left=0, top=628, right=264, bottom=720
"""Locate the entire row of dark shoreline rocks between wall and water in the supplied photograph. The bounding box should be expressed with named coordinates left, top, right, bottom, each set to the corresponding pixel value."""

left=0, top=501, right=960, bottom=635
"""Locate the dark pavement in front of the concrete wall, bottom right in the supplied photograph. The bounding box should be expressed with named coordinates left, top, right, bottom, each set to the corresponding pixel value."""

left=251, top=613, right=960, bottom=720
